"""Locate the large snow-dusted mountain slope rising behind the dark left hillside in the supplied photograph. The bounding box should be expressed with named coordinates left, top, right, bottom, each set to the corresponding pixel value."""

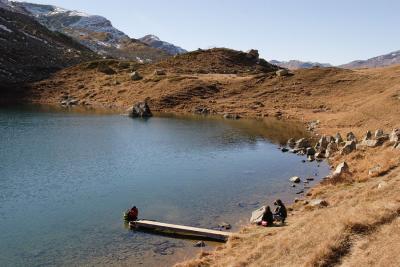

left=12, top=2, right=169, bottom=61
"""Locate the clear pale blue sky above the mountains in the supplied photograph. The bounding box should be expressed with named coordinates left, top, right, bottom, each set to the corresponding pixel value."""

left=13, top=0, right=400, bottom=64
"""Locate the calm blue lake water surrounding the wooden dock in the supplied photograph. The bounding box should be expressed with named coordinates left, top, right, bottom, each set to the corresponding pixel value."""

left=0, top=107, right=329, bottom=266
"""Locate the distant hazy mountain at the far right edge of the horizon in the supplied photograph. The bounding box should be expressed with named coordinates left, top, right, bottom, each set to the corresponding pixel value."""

left=339, top=50, right=400, bottom=69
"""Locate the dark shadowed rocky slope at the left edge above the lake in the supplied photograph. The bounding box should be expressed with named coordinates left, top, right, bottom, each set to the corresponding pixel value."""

left=0, top=5, right=98, bottom=86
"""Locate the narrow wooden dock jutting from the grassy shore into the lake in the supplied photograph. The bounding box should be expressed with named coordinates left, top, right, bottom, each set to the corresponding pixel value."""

left=129, top=220, right=233, bottom=241
